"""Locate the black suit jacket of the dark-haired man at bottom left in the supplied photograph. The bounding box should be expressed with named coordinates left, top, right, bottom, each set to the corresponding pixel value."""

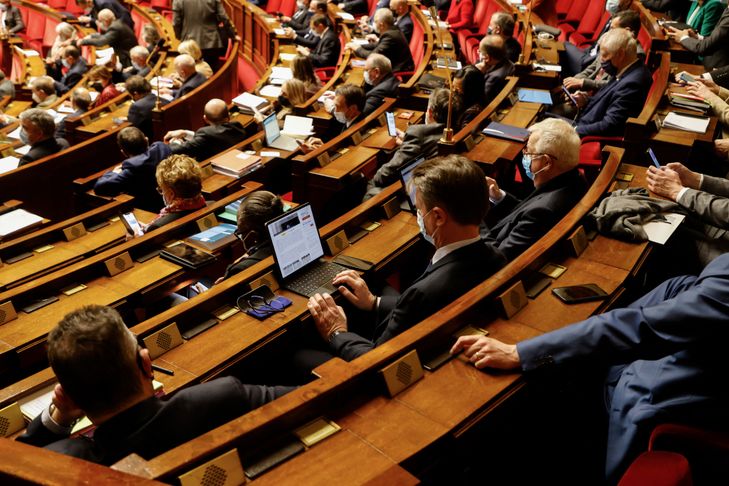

left=18, top=376, right=294, bottom=465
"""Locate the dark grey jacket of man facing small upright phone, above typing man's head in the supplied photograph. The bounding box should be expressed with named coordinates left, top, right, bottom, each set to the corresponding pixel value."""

left=372, top=123, right=445, bottom=187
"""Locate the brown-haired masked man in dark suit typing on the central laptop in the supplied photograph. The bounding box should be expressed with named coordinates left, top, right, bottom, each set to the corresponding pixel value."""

left=302, top=155, right=505, bottom=365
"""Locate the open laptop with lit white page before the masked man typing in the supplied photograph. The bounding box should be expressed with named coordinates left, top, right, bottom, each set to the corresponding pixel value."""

left=266, top=203, right=347, bottom=297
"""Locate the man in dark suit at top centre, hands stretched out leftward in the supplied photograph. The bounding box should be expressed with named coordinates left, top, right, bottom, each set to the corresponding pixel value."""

left=346, top=8, right=415, bottom=72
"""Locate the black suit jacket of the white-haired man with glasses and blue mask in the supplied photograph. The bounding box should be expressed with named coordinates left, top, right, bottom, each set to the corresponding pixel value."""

left=481, top=169, right=587, bottom=261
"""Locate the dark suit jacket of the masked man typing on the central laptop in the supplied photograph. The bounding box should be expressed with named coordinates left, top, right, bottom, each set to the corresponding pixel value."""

left=329, top=241, right=506, bottom=361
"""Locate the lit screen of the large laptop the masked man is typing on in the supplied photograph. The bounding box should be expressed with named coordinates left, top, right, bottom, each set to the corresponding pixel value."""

left=266, top=204, right=324, bottom=279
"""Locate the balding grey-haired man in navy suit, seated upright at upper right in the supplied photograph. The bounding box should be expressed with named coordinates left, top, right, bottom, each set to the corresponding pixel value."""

left=573, top=29, right=652, bottom=137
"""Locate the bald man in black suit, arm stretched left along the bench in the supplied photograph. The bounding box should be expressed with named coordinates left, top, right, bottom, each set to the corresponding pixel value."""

left=164, top=98, right=247, bottom=162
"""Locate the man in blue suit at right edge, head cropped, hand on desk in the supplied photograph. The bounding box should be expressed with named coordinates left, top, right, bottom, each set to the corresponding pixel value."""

left=451, top=254, right=729, bottom=482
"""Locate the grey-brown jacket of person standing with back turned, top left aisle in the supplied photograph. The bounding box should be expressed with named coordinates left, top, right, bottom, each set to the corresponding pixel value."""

left=172, top=0, right=235, bottom=49
